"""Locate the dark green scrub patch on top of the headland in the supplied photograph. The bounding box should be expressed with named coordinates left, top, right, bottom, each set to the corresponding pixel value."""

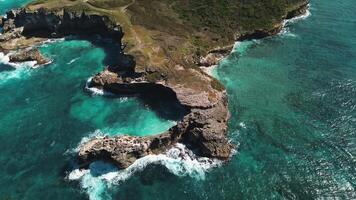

left=172, top=0, right=305, bottom=37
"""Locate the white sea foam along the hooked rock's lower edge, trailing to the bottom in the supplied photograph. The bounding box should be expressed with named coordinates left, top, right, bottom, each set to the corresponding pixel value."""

left=67, top=143, right=222, bottom=200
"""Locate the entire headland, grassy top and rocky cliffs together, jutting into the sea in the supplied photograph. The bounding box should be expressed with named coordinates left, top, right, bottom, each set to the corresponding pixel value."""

left=0, top=0, right=308, bottom=168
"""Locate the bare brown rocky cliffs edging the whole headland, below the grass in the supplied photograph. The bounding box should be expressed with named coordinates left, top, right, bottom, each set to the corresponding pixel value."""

left=0, top=0, right=308, bottom=168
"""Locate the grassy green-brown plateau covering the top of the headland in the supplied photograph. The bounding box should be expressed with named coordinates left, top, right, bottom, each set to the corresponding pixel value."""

left=27, top=0, right=308, bottom=95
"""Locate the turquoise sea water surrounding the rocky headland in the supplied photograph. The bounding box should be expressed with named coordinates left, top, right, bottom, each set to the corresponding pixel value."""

left=0, top=0, right=356, bottom=200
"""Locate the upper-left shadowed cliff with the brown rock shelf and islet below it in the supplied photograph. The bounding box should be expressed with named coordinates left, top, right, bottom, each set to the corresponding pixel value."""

left=0, top=8, right=126, bottom=66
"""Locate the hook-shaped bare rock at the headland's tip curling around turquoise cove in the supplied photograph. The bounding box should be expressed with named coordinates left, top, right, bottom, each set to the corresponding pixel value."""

left=78, top=70, right=233, bottom=168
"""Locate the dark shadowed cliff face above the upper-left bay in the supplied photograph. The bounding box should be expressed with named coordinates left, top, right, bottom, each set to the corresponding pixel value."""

left=0, top=8, right=123, bottom=39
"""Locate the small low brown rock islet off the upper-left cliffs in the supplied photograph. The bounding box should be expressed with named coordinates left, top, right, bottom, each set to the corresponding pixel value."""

left=9, top=49, right=50, bottom=65
